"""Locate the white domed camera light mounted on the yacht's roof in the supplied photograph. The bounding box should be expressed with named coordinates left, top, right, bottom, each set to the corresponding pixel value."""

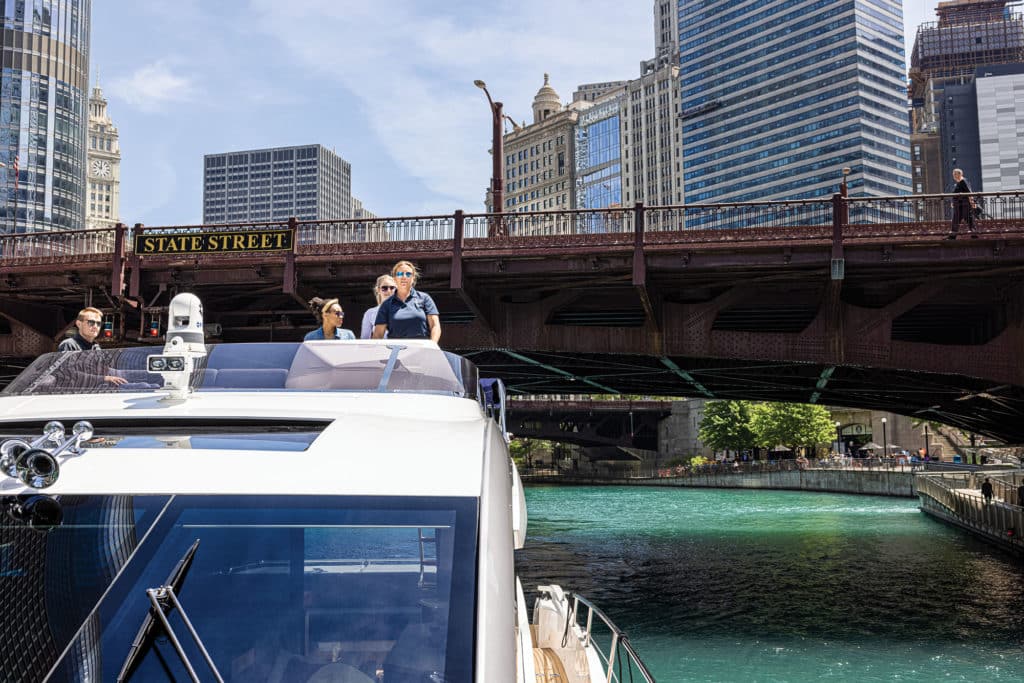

left=146, top=294, right=206, bottom=400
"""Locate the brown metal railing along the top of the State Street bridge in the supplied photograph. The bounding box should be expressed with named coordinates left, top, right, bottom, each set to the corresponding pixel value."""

left=6, top=191, right=1024, bottom=265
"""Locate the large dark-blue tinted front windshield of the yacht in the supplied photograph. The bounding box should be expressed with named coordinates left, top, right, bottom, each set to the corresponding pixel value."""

left=0, top=496, right=477, bottom=683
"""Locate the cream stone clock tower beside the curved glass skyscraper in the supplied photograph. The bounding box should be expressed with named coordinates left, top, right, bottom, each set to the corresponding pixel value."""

left=85, top=83, right=121, bottom=228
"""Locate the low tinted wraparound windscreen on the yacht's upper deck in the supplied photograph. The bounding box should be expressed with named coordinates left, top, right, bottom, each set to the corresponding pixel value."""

left=2, top=341, right=478, bottom=398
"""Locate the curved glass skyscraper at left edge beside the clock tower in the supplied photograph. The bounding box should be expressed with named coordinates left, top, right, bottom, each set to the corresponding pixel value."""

left=0, top=0, right=91, bottom=232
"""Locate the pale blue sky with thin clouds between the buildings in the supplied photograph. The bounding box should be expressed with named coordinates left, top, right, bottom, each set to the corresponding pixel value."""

left=91, top=0, right=937, bottom=225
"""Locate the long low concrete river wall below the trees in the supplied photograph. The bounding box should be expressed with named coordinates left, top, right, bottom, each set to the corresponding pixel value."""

left=523, top=469, right=918, bottom=498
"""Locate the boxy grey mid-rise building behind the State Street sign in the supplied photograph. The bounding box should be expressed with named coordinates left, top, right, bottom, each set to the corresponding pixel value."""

left=203, top=144, right=352, bottom=223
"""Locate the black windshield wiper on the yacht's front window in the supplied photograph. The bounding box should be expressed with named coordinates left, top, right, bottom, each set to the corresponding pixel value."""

left=118, top=539, right=224, bottom=683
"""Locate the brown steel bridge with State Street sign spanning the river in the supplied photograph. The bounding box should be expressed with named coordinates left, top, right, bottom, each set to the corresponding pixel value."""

left=0, top=194, right=1024, bottom=443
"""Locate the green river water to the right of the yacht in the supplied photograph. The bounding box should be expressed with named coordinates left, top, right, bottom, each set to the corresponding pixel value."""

left=517, top=486, right=1024, bottom=683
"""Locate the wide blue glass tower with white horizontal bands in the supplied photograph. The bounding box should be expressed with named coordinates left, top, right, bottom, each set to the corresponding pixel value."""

left=679, top=0, right=910, bottom=204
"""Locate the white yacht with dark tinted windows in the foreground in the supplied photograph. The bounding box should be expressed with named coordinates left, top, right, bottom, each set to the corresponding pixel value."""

left=0, top=295, right=653, bottom=683
